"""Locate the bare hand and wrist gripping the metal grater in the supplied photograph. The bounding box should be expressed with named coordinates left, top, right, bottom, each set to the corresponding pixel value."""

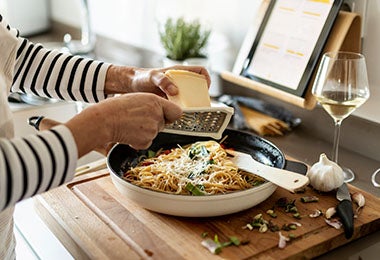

left=63, top=93, right=182, bottom=157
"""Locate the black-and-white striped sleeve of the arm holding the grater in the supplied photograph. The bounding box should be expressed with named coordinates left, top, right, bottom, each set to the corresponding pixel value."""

left=0, top=125, right=78, bottom=212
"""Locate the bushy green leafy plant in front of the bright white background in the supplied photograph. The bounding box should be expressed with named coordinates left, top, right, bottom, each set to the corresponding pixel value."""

left=159, top=18, right=211, bottom=60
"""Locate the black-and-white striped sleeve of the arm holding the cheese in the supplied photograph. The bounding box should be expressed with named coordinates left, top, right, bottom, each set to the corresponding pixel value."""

left=0, top=15, right=110, bottom=103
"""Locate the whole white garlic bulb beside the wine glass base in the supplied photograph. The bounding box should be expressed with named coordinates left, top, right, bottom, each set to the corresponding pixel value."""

left=306, top=153, right=344, bottom=192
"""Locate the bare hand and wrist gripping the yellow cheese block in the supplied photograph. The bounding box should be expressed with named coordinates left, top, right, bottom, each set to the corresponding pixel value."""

left=105, top=65, right=211, bottom=97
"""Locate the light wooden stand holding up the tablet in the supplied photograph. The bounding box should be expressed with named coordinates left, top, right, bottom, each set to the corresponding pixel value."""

left=221, top=9, right=361, bottom=110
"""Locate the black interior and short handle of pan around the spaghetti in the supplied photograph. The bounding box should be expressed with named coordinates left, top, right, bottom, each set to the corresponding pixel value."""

left=107, top=129, right=307, bottom=176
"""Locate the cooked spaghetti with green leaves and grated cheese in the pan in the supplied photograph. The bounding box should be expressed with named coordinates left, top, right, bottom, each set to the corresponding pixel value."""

left=123, top=140, right=265, bottom=195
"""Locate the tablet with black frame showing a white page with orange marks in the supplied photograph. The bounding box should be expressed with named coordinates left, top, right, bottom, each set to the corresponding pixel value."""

left=241, top=0, right=343, bottom=96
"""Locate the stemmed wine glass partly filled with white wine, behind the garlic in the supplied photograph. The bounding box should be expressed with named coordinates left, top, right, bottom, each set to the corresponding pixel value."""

left=312, top=51, right=369, bottom=182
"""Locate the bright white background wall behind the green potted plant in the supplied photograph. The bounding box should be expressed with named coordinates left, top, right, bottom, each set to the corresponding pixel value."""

left=51, top=0, right=260, bottom=70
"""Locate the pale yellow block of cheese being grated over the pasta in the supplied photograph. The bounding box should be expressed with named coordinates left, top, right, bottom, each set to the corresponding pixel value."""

left=165, top=70, right=211, bottom=108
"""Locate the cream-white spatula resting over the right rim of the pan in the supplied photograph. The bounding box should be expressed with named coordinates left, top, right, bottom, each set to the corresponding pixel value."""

left=228, top=150, right=309, bottom=192
